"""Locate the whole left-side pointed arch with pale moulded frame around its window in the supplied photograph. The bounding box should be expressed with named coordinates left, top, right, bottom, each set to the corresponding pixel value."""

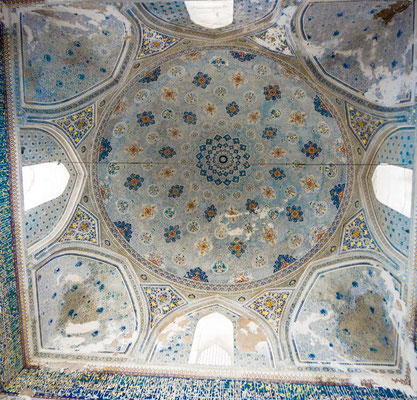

left=20, top=124, right=87, bottom=254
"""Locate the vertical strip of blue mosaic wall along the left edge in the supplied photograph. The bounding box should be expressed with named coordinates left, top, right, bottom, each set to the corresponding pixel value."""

left=0, top=23, right=23, bottom=391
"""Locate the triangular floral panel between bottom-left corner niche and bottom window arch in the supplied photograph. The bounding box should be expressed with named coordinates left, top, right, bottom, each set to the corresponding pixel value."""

left=142, top=285, right=188, bottom=328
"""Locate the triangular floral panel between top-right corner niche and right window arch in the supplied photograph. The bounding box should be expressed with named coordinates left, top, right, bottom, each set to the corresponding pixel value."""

left=346, top=104, right=388, bottom=150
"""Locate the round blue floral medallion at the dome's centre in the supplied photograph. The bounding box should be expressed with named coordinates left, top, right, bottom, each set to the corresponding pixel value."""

left=196, top=135, right=250, bottom=186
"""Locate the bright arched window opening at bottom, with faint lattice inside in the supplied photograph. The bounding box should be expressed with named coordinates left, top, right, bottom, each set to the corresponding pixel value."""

left=189, top=312, right=234, bottom=365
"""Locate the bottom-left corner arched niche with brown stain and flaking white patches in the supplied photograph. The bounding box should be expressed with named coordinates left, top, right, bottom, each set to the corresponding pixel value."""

left=28, top=244, right=148, bottom=361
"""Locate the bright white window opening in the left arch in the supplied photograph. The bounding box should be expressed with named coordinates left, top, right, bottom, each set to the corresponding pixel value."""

left=22, top=161, right=70, bottom=211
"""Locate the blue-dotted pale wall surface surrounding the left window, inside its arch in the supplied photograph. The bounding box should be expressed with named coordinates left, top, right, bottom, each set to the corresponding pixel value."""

left=20, top=129, right=77, bottom=245
